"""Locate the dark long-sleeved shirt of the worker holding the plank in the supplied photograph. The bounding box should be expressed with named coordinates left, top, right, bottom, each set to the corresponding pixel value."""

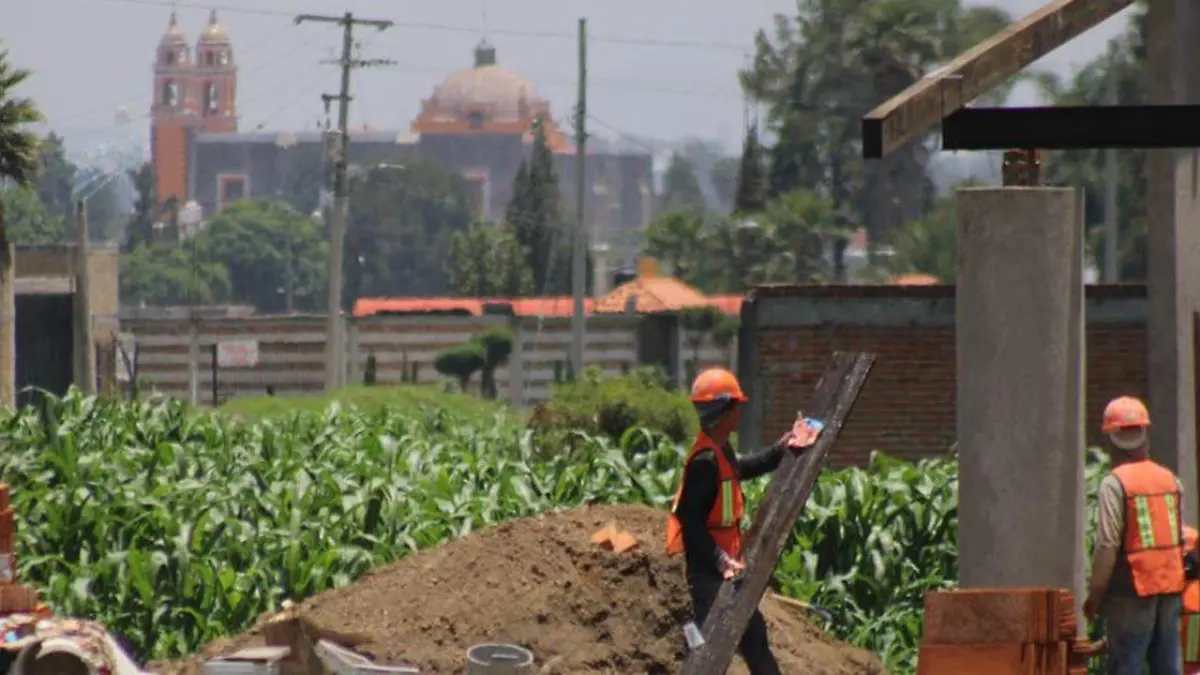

left=676, top=443, right=784, bottom=583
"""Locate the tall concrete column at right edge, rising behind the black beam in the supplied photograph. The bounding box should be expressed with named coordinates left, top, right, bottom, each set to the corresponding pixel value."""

left=1146, top=0, right=1200, bottom=522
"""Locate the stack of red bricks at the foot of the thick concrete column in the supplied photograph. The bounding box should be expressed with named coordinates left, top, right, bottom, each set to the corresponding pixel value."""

left=917, top=589, right=1096, bottom=675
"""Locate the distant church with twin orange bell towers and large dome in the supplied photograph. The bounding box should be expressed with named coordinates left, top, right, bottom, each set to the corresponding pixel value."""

left=151, top=11, right=654, bottom=267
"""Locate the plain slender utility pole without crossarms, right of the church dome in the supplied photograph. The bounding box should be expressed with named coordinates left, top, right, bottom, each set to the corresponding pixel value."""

left=571, top=19, right=588, bottom=377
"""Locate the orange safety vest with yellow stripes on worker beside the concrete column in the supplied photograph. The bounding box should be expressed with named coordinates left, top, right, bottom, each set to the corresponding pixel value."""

left=1112, top=460, right=1184, bottom=597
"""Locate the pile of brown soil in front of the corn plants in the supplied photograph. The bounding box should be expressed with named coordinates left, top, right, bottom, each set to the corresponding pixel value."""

left=151, top=507, right=883, bottom=675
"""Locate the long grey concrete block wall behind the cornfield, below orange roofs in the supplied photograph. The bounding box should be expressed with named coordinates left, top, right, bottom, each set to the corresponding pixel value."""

left=121, top=315, right=640, bottom=406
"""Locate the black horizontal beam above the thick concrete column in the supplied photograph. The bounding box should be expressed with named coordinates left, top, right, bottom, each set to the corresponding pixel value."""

left=942, top=106, right=1200, bottom=150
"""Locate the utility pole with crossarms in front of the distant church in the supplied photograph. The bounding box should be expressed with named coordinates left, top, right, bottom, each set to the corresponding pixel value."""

left=295, top=12, right=392, bottom=390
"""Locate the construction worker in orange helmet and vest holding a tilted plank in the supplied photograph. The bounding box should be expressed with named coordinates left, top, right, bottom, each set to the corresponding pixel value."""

left=666, top=368, right=815, bottom=675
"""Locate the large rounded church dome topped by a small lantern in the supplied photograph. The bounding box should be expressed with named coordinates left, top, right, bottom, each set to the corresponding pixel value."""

left=428, top=42, right=545, bottom=121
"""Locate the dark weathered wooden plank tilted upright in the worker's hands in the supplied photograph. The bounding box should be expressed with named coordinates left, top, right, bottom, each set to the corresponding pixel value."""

left=683, top=353, right=875, bottom=675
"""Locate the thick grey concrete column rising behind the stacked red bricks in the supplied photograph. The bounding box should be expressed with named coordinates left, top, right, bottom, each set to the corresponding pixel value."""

left=955, top=187, right=1085, bottom=601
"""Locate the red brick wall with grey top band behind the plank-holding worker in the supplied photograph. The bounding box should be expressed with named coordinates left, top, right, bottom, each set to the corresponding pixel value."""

left=739, top=286, right=1146, bottom=465
